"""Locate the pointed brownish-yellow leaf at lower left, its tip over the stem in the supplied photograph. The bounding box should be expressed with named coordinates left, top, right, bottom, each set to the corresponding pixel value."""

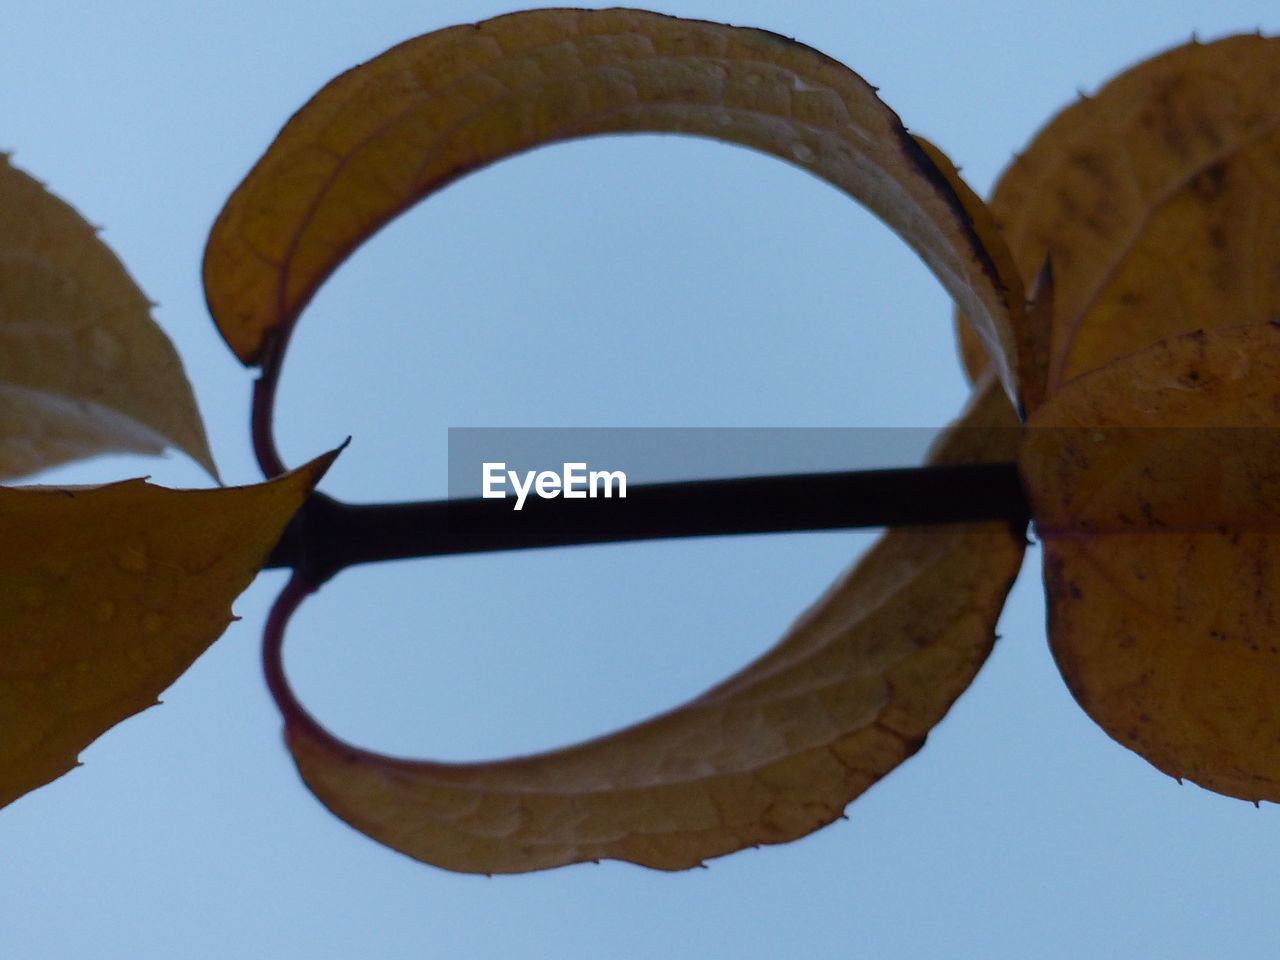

left=0, top=453, right=337, bottom=806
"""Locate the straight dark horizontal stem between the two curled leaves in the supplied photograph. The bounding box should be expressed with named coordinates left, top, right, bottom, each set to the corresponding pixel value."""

left=266, top=463, right=1029, bottom=586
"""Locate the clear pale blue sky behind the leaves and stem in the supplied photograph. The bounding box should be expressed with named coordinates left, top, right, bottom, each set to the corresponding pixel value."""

left=0, top=0, right=1280, bottom=960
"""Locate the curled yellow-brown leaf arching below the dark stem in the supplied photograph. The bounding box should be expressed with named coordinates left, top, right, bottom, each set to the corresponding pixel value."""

left=268, top=378, right=1023, bottom=873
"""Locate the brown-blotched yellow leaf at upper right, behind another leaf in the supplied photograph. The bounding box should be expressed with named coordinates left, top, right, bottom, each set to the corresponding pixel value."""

left=960, top=36, right=1280, bottom=394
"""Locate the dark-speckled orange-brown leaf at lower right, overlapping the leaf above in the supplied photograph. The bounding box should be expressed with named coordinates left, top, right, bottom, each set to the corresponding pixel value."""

left=1019, top=324, right=1280, bottom=801
